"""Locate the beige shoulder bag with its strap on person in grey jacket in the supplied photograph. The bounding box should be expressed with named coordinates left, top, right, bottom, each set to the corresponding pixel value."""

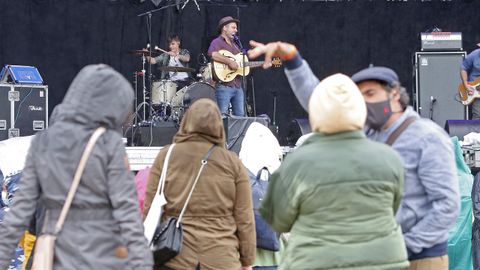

left=32, top=127, right=106, bottom=270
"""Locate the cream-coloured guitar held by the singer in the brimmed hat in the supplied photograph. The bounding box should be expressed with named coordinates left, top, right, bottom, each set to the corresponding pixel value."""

left=213, top=50, right=282, bottom=82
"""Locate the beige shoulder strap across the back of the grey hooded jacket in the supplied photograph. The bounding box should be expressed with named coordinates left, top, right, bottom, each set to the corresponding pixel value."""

left=55, top=127, right=106, bottom=235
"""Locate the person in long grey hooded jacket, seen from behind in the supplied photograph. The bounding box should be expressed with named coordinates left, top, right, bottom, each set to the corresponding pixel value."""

left=0, top=64, right=153, bottom=269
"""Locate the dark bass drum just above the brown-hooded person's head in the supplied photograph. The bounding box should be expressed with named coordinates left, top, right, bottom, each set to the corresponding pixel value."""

left=172, top=82, right=216, bottom=109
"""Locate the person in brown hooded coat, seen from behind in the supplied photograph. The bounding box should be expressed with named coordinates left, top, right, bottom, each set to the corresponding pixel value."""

left=144, top=99, right=256, bottom=270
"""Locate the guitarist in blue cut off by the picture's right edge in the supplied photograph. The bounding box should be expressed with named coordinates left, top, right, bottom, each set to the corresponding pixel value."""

left=459, top=44, right=480, bottom=119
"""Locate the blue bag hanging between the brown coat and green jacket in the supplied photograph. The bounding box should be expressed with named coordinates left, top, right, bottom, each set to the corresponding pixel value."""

left=249, top=167, right=280, bottom=251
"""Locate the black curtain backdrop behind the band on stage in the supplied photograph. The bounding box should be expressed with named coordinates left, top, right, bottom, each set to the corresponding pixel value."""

left=0, top=0, right=480, bottom=146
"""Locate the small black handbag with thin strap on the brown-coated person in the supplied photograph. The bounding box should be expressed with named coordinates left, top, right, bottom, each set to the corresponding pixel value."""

left=151, top=145, right=215, bottom=265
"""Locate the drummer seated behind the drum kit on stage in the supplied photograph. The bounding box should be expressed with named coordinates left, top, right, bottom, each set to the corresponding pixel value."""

left=147, top=34, right=193, bottom=90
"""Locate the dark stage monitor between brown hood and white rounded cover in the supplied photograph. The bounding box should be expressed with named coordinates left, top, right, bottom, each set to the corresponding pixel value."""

left=223, top=116, right=270, bottom=155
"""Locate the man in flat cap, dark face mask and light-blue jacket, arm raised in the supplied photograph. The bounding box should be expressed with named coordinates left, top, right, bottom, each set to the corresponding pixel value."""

left=249, top=41, right=460, bottom=270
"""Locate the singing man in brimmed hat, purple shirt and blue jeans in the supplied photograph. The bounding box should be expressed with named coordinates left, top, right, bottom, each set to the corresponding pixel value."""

left=208, top=16, right=245, bottom=116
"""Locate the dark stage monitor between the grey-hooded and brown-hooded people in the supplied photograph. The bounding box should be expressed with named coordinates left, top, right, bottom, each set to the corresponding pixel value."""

left=125, top=122, right=178, bottom=146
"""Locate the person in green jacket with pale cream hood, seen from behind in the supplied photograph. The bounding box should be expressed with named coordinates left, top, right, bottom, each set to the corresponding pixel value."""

left=260, top=74, right=409, bottom=270
